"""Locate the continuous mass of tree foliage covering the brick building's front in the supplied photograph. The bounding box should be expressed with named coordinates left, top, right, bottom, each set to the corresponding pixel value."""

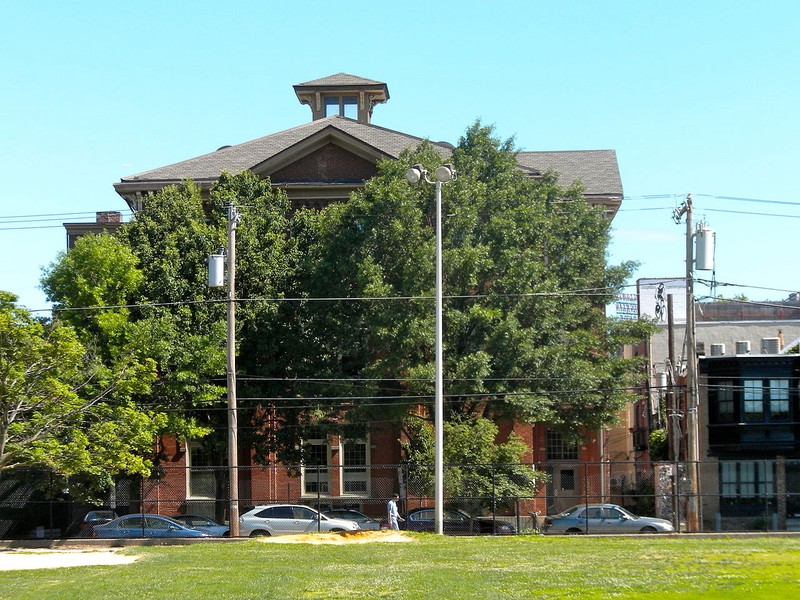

left=36, top=123, right=646, bottom=478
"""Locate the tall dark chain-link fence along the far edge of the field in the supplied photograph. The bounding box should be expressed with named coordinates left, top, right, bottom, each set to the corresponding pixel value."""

left=0, top=459, right=800, bottom=539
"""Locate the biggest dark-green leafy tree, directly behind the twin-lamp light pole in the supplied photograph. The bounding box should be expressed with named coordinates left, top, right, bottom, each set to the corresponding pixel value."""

left=268, top=123, right=645, bottom=454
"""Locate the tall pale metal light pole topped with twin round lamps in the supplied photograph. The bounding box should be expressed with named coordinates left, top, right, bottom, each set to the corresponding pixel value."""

left=406, top=165, right=456, bottom=535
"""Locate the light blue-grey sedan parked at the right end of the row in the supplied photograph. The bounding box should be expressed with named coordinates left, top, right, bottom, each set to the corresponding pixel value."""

left=542, top=504, right=675, bottom=533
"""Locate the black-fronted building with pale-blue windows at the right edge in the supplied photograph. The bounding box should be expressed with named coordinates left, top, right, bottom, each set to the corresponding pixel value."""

left=699, top=353, right=800, bottom=529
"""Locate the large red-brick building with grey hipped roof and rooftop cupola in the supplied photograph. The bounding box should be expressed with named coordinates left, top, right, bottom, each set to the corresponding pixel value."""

left=95, top=73, right=627, bottom=510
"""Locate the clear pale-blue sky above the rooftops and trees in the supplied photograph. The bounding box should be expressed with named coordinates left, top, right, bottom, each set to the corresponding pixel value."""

left=0, top=0, right=800, bottom=309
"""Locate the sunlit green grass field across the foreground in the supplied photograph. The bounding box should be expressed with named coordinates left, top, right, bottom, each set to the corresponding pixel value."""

left=0, top=534, right=800, bottom=600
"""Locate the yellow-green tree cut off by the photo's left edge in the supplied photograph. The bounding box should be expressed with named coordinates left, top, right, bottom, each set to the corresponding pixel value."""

left=0, top=292, right=163, bottom=498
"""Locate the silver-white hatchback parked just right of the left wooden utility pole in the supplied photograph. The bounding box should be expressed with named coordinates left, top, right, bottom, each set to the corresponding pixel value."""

left=239, top=504, right=360, bottom=537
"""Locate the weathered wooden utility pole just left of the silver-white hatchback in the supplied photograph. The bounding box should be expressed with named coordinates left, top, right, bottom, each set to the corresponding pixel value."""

left=227, top=201, right=240, bottom=537
